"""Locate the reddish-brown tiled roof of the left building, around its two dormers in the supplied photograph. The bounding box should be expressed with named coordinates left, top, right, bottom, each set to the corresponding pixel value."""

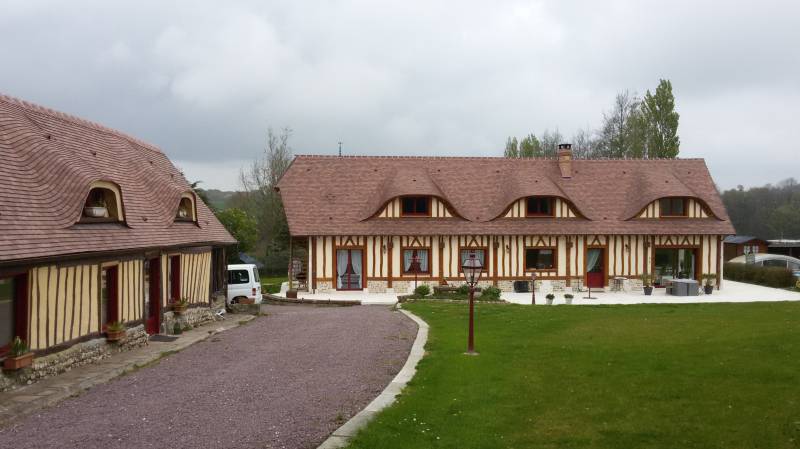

left=0, top=95, right=235, bottom=263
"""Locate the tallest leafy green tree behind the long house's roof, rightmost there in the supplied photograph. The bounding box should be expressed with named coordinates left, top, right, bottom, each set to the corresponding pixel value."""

left=641, top=79, right=681, bottom=158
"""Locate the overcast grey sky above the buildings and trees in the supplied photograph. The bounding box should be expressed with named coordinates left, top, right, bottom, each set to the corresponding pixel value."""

left=0, top=0, right=800, bottom=189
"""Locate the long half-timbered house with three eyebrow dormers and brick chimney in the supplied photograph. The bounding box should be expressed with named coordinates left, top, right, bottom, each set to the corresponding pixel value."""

left=278, top=145, right=734, bottom=292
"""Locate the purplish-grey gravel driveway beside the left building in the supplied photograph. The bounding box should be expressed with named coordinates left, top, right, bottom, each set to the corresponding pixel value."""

left=0, top=306, right=417, bottom=449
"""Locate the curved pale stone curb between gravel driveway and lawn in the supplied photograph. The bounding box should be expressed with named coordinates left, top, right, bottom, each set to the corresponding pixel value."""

left=317, top=304, right=428, bottom=449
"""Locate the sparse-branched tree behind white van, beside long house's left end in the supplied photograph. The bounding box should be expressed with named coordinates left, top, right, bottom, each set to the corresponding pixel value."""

left=238, top=128, right=292, bottom=273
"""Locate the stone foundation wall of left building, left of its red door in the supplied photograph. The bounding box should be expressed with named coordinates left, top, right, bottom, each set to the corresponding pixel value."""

left=0, top=324, right=147, bottom=391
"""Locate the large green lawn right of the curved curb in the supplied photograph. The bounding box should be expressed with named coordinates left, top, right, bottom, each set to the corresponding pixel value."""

left=350, top=301, right=800, bottom=449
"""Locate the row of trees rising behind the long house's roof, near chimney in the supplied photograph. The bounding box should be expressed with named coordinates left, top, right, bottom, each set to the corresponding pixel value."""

left=504, top=79, right=680, bottom=159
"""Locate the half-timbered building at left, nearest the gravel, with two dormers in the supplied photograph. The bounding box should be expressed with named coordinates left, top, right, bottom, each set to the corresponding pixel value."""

left=0, top=95, right=235, bottom=359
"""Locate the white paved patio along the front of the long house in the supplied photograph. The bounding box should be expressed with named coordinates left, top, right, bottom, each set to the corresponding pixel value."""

left=279, top=281, right=800, bottom=305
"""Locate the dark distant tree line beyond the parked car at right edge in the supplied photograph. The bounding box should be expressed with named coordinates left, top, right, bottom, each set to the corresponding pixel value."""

left=722, top=178, right=800, bottom=239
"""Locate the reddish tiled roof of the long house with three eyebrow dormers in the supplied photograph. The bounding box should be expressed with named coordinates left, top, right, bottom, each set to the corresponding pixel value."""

left=278, top=155, right=734, bottom=235
